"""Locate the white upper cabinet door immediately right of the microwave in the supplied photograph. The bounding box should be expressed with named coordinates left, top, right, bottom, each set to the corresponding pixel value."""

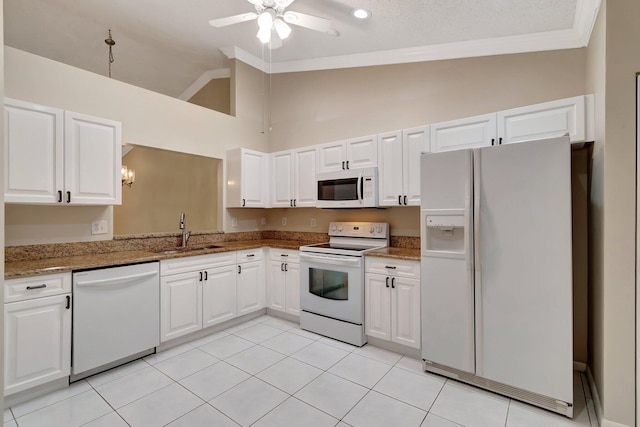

left=378, top=131, right=402, bottom=206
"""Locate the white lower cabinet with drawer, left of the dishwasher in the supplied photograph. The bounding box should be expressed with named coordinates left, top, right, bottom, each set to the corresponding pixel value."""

left=4, top=274, right=71, bottom=396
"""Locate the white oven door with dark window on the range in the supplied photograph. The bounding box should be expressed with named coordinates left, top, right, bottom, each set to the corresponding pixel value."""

left=300, top=252, right=364, bottom=325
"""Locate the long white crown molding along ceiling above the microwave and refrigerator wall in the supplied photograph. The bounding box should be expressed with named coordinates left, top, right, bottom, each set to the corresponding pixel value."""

left=220, top=0, right=601, bottom=74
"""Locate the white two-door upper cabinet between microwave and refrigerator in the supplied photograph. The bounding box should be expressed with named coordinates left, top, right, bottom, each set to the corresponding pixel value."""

left=378, top=126, right=430, bottom=206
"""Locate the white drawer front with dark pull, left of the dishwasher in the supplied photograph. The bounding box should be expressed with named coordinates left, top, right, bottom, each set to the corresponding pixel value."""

left=4, top=273, right=71, bottom=303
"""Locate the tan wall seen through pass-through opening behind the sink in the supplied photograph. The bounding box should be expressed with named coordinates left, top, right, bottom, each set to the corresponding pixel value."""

left=113, top=147, right=222, bottom=235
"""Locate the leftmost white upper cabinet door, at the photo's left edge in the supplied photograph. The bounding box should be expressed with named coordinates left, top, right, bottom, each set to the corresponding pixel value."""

left=4, top=99, right=64, bottom=203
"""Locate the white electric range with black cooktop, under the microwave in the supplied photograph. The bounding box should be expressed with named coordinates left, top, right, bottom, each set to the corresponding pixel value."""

left=300, top=222, right=389, bottom=346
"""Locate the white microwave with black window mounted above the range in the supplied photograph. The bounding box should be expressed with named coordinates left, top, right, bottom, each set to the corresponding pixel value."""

left=316, top=168, right=378, bottom=208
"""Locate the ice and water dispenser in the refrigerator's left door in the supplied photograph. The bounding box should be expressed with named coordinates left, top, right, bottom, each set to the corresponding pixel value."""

left=422, top=209, right=466, bottom=257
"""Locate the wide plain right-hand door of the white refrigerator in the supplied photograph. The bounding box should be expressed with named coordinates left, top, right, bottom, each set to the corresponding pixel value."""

left=474, top=138, right=573, bottom=403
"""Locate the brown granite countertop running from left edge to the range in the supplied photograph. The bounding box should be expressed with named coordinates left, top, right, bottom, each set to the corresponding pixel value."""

left=4, top=239, right=310, bottom=280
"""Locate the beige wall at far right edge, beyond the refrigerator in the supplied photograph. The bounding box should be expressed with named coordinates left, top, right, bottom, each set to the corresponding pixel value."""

left=589, top=0, right=640, bottom=425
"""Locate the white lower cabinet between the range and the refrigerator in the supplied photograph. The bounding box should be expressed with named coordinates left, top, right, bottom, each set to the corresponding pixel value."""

left=365, top=257, right=420, bottom=349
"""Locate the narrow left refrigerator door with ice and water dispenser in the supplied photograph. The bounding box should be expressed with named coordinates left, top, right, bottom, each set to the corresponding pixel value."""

left=420, top=150, right=475, bottom=373
